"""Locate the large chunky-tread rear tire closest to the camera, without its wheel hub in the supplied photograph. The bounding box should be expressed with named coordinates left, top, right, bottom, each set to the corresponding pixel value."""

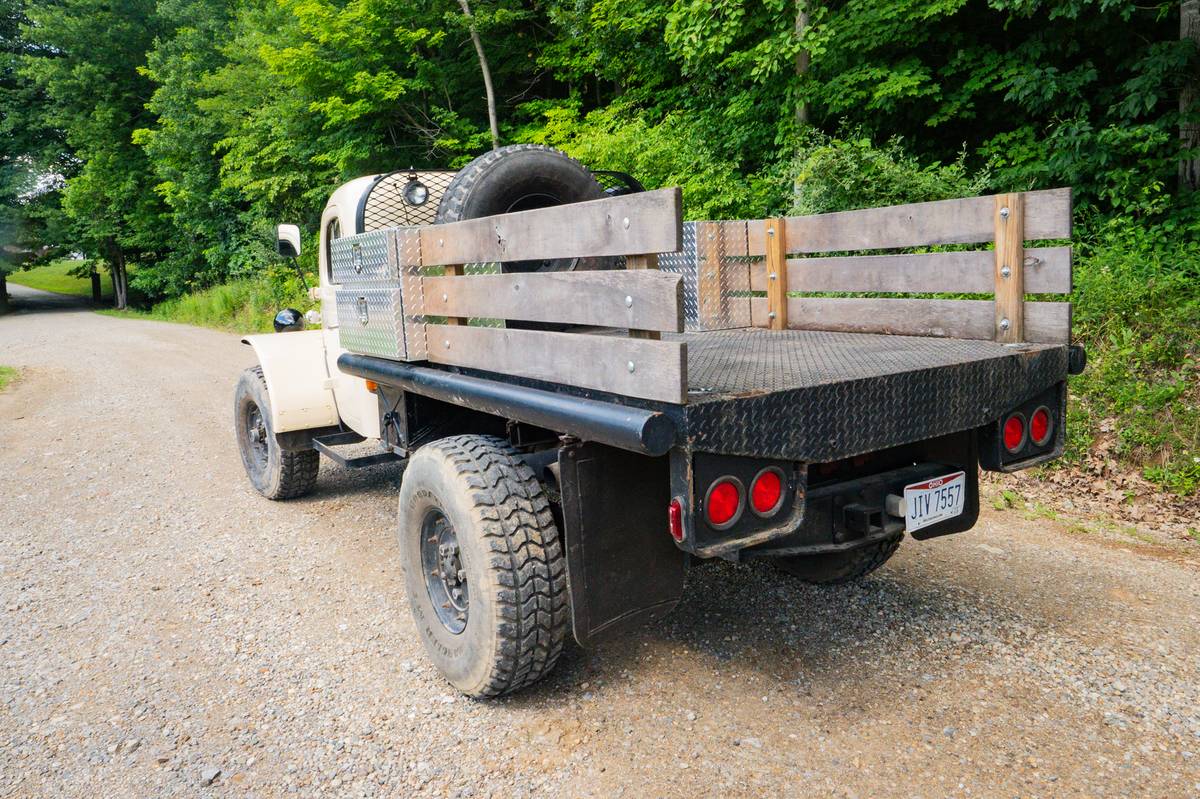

left=398, top=435, right=569, bottom=698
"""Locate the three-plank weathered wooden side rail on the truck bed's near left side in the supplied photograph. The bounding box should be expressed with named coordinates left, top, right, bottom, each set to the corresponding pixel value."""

left=401, top=188, right=688, bottom=404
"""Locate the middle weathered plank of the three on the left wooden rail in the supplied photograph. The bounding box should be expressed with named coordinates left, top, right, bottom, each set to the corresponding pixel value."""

left=421, top=271, right=683, bottom=332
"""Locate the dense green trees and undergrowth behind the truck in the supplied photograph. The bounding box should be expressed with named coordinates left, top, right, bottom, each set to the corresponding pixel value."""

left=0, top=0, right=1200, bottom=491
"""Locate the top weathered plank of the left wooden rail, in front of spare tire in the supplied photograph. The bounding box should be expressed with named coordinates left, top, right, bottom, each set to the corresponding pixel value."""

left=421, top=188, right=683, bottom=266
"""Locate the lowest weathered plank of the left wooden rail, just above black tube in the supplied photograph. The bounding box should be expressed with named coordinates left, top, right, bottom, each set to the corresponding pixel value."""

left=426, top=325, right=688, bottom=404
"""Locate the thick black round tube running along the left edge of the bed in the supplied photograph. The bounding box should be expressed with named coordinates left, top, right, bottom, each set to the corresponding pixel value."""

left=337, top=353, right=676, bottom=456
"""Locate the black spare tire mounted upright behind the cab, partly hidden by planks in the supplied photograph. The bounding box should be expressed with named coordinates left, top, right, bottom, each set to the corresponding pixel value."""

left=436, top=144, right=616, bottom=272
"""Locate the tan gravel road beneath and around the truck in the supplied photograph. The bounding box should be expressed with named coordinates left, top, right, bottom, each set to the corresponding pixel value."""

left=0, top=295, right=1200, bottom=798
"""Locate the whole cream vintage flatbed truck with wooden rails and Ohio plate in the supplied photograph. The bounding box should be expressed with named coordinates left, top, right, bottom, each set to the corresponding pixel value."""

left=234, top=145, right=1085, bottom=697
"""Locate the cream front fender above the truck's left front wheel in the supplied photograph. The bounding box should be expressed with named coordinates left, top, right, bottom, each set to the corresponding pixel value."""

left=241, top=330, right=338, bottom=433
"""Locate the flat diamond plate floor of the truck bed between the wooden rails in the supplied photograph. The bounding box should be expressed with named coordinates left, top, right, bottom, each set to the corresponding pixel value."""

left=664, top=329, right=1054, bottom=403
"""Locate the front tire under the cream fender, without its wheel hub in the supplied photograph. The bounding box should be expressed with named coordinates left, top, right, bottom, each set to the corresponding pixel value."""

left=233, top=366, right=320, bottom=499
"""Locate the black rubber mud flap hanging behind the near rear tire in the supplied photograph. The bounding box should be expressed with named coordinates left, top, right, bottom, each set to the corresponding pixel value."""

left=558, top=444, right=688, bottom=647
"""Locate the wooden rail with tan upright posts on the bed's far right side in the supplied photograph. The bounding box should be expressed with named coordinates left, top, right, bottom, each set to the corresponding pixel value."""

left=697, top=188, right=1072, bottom=344
